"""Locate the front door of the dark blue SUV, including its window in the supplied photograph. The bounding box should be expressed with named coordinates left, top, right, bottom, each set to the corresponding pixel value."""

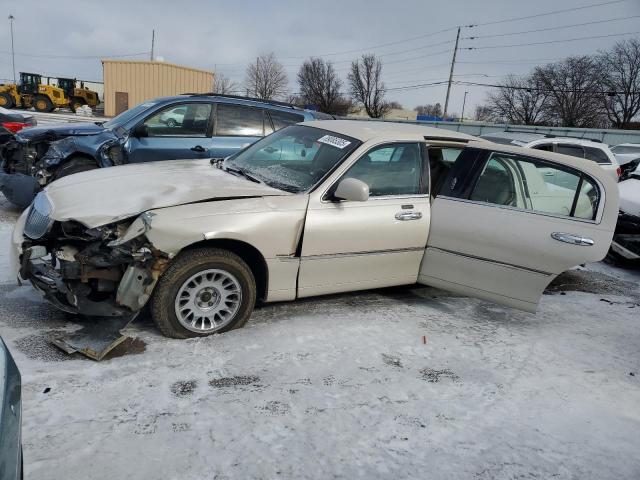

left=127, top=103, right=213, bottom=163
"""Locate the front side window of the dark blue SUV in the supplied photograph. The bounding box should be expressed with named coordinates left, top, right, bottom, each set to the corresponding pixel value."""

left=144, top=103, right=212, bottom=137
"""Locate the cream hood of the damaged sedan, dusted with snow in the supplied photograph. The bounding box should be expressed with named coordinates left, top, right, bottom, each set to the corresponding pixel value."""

left=44, top=159, right=291, bottom=228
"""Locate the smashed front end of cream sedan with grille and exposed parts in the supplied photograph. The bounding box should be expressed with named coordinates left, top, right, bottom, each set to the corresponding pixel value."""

left=13, top=192, right=169, bottom=316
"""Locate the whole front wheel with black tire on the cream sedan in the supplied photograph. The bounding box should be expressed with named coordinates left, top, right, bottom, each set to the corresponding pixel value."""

left=151, top=247, right=256, bottom=339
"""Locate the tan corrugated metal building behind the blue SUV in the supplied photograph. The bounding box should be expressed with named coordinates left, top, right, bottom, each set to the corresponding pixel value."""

left=102, top=60, right=213, bottom=117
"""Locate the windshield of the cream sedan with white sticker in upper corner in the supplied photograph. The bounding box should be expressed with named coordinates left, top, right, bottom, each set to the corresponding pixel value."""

left=225, top=125, right=361, bottom=193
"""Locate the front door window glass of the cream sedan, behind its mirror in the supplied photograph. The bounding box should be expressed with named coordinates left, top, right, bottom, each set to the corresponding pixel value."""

left=343, top=143, right=427, bottom=197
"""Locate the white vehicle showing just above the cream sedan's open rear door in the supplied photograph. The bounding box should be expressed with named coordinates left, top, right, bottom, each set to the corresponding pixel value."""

left=523, top=137, right=622, bottom=182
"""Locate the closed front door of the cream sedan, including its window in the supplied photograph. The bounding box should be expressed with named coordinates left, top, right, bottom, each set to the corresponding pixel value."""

left=298, top=142, right=430, bottom=297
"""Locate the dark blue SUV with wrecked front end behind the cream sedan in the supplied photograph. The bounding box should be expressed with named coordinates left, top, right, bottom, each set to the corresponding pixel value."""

left=0, top=94, right=332, bottom=207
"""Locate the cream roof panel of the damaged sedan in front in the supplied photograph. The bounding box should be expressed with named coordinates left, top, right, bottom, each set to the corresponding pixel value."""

left=301, top=120, right=478, bottom=142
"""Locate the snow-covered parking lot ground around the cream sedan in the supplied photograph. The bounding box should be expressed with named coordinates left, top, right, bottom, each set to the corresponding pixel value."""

left=0, top=197, right=640, bottom=480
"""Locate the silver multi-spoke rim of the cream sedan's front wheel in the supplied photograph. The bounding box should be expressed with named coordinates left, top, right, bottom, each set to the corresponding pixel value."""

left=174, top=269, right=242, bottom=333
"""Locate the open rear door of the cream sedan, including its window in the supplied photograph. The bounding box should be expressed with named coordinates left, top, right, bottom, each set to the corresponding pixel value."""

left=418, top=148, right=617, bottom=311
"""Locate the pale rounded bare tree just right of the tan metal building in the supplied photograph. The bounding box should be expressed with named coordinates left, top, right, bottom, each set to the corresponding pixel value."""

left=245, top=52, right=289, bottom=100
